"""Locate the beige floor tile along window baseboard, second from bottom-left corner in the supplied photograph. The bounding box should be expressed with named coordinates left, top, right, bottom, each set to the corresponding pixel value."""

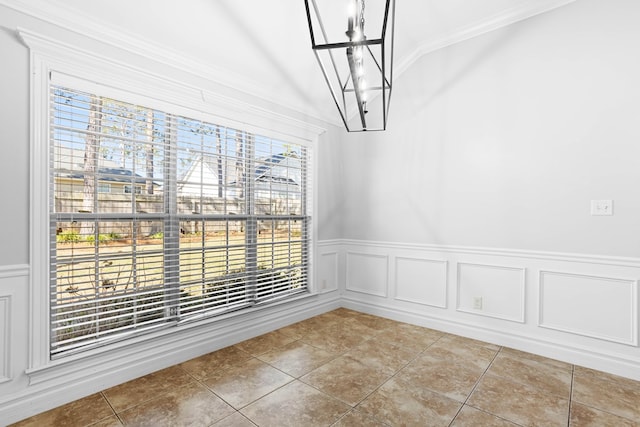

left=103, top=366, right=195, bottom=413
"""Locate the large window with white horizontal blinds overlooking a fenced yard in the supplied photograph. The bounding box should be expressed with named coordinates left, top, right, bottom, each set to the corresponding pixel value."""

left=49, top=86, right=310, bottom=358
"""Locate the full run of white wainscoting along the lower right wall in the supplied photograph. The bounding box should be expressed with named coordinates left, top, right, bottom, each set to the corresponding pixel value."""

left=332, top=239, right=640, bottom=380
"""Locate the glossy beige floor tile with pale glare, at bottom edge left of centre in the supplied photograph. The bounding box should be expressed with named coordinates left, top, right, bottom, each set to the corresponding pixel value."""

left=241, top=380, right=351, bottom=427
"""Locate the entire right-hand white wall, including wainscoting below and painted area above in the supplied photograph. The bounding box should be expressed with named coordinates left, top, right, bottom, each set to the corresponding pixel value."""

left=312, top=0, right=640, bottom=379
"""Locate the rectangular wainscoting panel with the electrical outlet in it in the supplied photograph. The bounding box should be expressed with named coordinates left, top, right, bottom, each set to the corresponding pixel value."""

left=457, top=263, right=526, bottom=322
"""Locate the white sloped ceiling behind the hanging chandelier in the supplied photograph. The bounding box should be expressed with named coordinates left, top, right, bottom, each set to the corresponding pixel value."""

left=5, top=0, right=574, bottom=123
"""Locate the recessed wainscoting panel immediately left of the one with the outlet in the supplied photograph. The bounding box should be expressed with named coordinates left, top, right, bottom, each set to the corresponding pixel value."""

left=395, top=256, right=448, bottom=308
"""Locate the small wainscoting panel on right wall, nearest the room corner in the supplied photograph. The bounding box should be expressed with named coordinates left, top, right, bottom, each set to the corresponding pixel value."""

left=346, top=252, right=389, bottom=298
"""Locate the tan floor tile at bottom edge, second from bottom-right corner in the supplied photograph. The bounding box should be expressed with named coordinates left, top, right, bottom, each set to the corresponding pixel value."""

left=467, top=374, right=569, bottom=427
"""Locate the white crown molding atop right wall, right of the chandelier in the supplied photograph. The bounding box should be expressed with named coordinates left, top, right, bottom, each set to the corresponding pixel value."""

left=395, top=0, right=576, bottom=77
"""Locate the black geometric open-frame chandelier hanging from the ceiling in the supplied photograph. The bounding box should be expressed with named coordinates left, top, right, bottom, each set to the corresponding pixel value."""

left=304, top=0, right=396, bottom=132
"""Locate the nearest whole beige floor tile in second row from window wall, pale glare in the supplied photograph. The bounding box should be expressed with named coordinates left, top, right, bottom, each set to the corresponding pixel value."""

left=204, top=359, right=294, bottom=409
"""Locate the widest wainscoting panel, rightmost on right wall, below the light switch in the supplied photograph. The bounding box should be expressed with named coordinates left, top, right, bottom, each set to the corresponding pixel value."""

left=540, top=271, right=638, bottom=345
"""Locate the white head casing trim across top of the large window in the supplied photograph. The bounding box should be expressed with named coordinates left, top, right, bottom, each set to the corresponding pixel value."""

left=18, top=28, right=326, bottom=142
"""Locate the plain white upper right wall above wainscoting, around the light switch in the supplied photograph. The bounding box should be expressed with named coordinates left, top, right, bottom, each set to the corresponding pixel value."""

left=341, top=0, right=640, bottom=257
